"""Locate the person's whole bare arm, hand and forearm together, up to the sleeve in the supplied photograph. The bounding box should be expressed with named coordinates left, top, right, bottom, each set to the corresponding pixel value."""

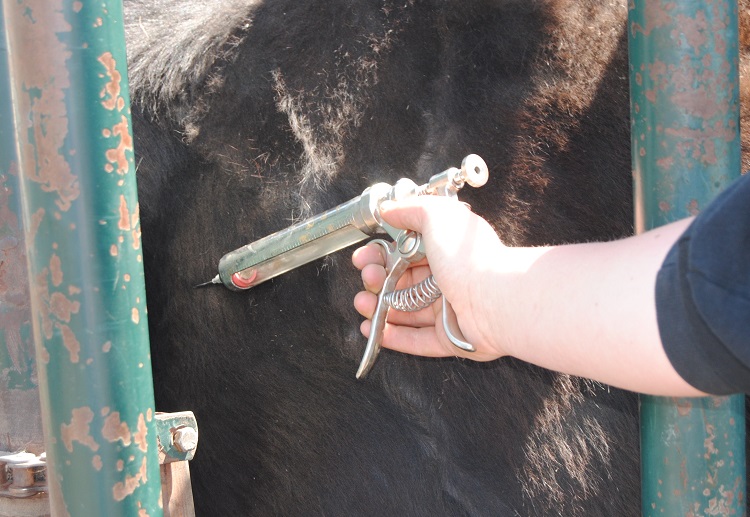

left=352, top=196, right=705, bottom=396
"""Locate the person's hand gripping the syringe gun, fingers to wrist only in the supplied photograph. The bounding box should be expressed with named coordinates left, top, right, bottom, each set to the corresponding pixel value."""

left=352, top=196, right=506, bottom=361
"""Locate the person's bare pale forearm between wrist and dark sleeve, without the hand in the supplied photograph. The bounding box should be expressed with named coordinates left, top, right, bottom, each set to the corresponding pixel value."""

left=482, top=220, right=700, bottom=396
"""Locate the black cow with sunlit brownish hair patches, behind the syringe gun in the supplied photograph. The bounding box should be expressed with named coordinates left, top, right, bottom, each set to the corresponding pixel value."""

left=125, top=0, right=748, bottom=516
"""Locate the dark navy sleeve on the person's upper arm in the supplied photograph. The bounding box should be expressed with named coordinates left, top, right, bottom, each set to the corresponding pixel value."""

left=656, top=175, right=750, bottom=395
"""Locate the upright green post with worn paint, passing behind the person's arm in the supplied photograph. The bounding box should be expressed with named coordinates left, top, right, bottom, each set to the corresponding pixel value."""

left=629, top=0, right=746, bottom=516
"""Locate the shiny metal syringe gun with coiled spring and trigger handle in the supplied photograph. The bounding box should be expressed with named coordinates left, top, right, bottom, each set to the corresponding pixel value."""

left=208, top=154, right=489, bottom=378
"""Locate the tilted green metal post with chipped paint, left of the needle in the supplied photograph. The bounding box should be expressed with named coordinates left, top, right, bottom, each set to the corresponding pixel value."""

left=2, top=0, right=162, bottom=517
